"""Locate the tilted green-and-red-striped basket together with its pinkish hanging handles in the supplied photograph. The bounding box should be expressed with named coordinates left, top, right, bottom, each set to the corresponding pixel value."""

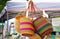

left=28, top=1, right=53, bottom=38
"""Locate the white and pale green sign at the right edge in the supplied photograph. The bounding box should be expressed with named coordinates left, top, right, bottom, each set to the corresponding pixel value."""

left=52, top=18, right=60, bottom=32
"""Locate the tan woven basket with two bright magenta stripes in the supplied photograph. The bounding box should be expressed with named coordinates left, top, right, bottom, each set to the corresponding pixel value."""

left=20, top=17, right=35, bottom=36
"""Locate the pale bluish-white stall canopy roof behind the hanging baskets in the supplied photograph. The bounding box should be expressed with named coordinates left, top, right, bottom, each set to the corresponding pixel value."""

left=7, top=1, right=60, bottom=11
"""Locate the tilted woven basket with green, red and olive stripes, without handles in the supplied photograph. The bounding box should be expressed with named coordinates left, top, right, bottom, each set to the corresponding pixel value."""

left=34, top=16, right=53, bottom=37
